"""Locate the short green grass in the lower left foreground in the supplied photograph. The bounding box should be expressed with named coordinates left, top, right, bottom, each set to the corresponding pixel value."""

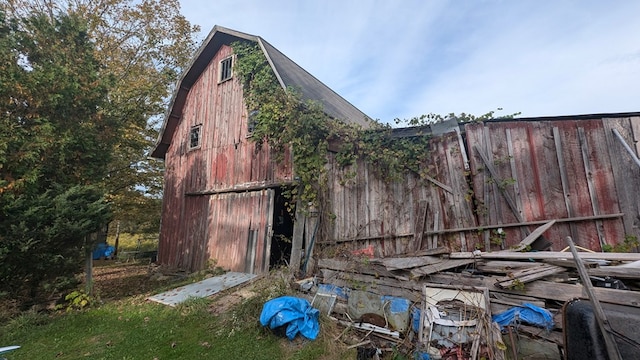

left=0, top=300, right=281, bottom=360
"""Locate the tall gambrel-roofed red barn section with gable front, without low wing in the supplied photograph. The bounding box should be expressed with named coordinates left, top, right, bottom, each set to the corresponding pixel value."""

left=152, top=26, right=367, bottom=273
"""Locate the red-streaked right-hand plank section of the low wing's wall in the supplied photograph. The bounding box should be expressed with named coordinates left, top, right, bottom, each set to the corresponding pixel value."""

left=465, top=119, right=640, bottom=251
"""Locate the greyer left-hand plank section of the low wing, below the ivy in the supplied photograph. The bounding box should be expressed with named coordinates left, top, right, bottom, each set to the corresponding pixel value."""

left=319, top=133, right=476, bottom=256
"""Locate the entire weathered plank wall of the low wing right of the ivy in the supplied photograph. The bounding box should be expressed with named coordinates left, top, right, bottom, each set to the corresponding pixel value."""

left=319, top=117, right=640, bottom=256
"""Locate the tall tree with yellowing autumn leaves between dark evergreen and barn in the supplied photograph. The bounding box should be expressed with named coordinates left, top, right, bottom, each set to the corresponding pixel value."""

left=7, top=0, right=199, bottom=238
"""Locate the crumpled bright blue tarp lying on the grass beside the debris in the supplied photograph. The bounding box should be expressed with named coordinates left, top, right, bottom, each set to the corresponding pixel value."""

left=260, top=296, right=320, bottom=340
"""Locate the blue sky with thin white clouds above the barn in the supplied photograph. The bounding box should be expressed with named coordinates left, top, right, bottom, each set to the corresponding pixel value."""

left=181, top=0, right=640, bottom=122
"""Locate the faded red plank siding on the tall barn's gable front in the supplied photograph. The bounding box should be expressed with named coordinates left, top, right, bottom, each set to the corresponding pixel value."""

left=158, top=46, right=292, bottom=270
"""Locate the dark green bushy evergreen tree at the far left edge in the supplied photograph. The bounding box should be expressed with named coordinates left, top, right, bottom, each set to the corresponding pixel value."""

left=0, top=10, right=116, bottom=299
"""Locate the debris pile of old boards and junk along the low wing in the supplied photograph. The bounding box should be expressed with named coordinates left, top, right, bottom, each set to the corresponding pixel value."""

left=312, top=243, right=640, bottom=360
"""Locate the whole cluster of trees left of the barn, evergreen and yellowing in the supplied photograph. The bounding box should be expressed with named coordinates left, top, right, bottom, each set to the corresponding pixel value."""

left=0, top=0, right=199, bottom=302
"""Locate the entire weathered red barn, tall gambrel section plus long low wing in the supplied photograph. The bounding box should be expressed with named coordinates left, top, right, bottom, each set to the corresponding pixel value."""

left=152, top=27, right=640, bottom=273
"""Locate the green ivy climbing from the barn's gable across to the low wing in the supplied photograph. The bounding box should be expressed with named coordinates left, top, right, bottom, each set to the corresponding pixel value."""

left=232, top=42, right=435, bottom=210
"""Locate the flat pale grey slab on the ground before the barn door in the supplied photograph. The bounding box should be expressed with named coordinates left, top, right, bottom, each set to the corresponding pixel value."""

left=147, top=272, right=257, bottom=306
